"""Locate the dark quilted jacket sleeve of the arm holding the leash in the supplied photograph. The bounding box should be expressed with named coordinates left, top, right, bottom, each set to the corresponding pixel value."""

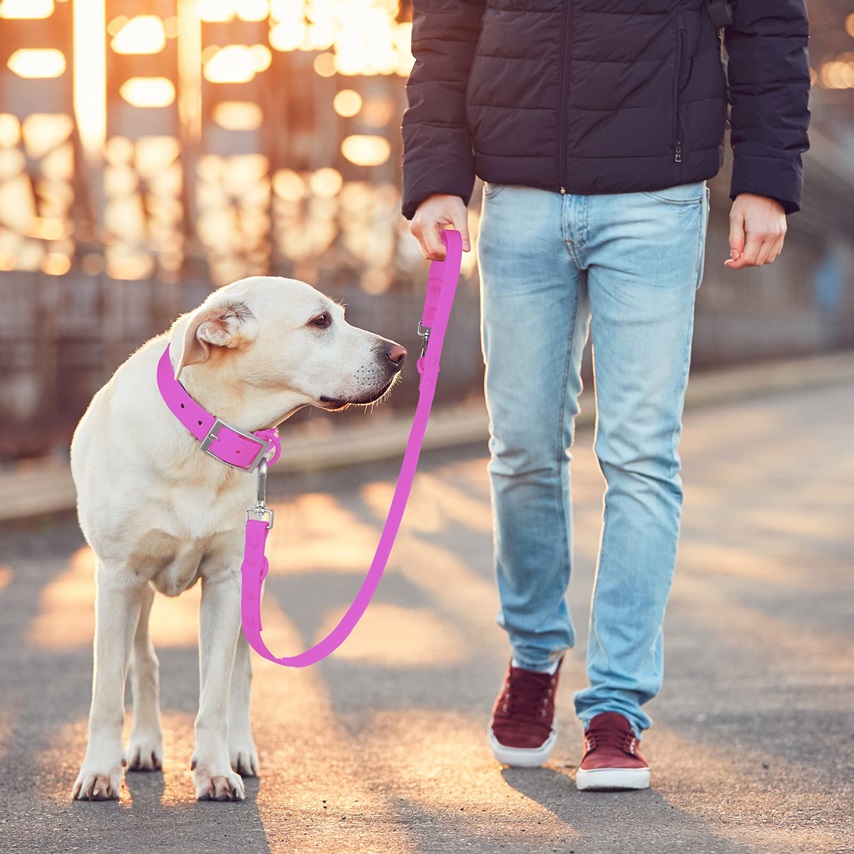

left=403, top=0, right=485, bottom=224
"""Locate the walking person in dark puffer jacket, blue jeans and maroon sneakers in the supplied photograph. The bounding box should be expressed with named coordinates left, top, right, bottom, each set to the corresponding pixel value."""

left=402, top=0, right=810, bottom=789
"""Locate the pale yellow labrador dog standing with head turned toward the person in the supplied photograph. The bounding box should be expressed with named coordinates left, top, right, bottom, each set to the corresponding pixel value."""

left=71, top=276, right=406, bottom=800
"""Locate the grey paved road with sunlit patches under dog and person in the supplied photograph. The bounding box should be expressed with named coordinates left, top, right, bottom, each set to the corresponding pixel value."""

left=0, top=385, right=854, bottom=854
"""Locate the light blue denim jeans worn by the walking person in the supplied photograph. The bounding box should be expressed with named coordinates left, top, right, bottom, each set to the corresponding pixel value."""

left=478, top=183, right=708, bottom=734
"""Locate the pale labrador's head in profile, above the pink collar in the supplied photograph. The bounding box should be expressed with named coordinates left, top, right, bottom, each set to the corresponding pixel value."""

left=170, top=276, right=406, bottom=426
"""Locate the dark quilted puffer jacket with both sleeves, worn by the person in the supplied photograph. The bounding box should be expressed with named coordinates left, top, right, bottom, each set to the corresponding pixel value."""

left=403, top=0, right=810, bottom=218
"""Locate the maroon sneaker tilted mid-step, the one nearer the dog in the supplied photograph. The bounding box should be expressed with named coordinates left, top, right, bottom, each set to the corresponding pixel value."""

left=489, top=659, right=563, bottom=768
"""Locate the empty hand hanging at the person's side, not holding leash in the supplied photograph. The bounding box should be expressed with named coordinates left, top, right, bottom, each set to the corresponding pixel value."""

left=724, top=193, right=786, bottom=270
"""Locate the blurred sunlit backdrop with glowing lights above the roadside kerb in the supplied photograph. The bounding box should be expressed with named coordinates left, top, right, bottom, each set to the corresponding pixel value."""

left=0, top=0, right=854, bottom=462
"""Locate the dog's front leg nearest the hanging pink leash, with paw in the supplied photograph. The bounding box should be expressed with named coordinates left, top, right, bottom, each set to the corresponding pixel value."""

left=193, top=573, right=244, bottom=801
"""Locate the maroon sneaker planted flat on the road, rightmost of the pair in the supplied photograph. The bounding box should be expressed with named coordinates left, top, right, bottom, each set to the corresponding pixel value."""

left=575, top=712, right=649, bottom=791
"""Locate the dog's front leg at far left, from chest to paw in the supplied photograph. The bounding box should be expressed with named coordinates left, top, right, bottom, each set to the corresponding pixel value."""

left=72, top=561, right=140, bottom=801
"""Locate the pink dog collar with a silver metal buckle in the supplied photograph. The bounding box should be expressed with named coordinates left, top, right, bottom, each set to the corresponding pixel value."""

left=157, top=345, right=281, bottom=472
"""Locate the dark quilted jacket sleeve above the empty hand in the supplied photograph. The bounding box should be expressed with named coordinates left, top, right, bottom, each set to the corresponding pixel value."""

left=725, top=0, right=810, bottom=213
